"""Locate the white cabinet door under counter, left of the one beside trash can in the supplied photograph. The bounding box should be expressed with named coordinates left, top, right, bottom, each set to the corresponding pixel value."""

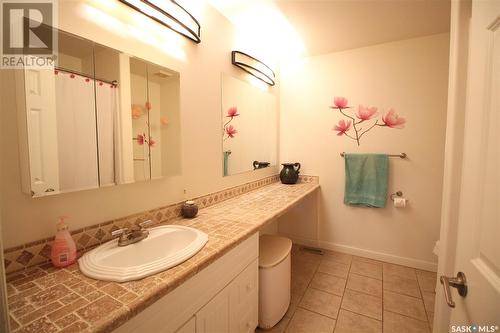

left=196, top=287, right=235, bottom=333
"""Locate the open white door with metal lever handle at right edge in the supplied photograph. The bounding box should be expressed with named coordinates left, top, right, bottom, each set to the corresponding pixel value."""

left=436, top=0, right=500, bottom=326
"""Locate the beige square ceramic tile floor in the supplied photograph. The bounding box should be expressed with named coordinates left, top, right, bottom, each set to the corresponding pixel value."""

left=256, top=245, right=436, bottom=333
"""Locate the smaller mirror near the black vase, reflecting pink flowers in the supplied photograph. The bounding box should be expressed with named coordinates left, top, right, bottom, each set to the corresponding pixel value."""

left=222, top=74, right=278, bottom=176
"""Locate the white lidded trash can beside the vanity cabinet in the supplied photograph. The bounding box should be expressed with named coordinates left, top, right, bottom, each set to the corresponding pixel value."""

left=259, top=235, right=292, bottom=329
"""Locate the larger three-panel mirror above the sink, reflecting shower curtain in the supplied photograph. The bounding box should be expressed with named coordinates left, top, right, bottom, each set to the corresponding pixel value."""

left=16, top=31, right=181, bottom=197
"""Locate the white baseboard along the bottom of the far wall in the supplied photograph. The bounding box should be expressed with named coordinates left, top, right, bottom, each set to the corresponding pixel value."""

left=286, top=235, right=437, bottom=272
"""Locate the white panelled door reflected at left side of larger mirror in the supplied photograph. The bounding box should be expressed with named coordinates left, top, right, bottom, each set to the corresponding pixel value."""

left=24, top=68, right=59, bottom=196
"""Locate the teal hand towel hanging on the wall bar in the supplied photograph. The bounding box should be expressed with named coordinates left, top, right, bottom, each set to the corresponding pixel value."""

left=344, top=154, right=389, bottom=208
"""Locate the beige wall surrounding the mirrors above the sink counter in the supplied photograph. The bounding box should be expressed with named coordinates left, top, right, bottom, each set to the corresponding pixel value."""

left=0, top=0, right=276, bottom=248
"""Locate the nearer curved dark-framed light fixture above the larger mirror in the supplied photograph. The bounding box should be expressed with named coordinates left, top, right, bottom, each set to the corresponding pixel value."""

left=120, top=0, right=201, bottom=44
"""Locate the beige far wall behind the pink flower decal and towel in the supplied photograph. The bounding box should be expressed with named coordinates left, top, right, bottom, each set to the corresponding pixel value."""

left=280, top=34, right=449, bottom=269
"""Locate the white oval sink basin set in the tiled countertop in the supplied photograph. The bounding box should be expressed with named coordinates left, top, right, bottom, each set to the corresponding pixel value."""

left=78, top=225, right=208, bottom=282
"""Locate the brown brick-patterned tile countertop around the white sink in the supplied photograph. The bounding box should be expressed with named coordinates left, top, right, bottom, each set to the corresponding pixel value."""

left=7, top=183, right=319, bottom=333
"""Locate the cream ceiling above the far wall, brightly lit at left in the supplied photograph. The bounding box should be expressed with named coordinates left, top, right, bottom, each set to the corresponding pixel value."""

left=210, top=0, right=450, bottom=55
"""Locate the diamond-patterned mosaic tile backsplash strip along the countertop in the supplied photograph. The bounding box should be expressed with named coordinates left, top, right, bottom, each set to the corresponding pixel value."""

left=4, top=175, right=319, bottom=273
